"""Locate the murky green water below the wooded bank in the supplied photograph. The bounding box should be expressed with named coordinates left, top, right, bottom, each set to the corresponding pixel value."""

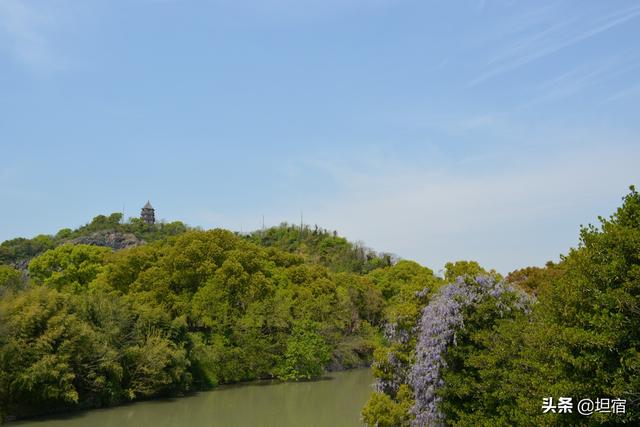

left=12, top=369, right=373, bottom=427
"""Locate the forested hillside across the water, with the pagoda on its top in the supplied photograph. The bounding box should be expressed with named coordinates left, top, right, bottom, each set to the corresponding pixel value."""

left=0, top=219, right=439, bottom=417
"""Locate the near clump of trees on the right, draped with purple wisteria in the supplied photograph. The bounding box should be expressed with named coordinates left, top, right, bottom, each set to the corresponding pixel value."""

left=363, top=187, right=640, bottom=427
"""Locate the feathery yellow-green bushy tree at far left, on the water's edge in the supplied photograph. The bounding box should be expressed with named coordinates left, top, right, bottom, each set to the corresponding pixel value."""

left=0, top=287, right=121, bottom=414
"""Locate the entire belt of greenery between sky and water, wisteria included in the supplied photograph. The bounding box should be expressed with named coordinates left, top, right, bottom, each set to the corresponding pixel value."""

left=0, top=187, right=640, bottom=427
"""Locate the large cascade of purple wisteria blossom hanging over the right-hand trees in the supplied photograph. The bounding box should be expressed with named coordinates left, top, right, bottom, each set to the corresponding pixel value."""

left=408, top=276, right=532, bottom=426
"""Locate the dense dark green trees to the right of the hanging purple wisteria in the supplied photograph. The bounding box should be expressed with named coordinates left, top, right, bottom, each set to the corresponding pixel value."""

left=428, top=187, right=640, bottom=426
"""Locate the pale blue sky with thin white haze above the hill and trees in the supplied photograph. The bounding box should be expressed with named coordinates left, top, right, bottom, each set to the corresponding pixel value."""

left=0, top=0, right=640, bottom=272
